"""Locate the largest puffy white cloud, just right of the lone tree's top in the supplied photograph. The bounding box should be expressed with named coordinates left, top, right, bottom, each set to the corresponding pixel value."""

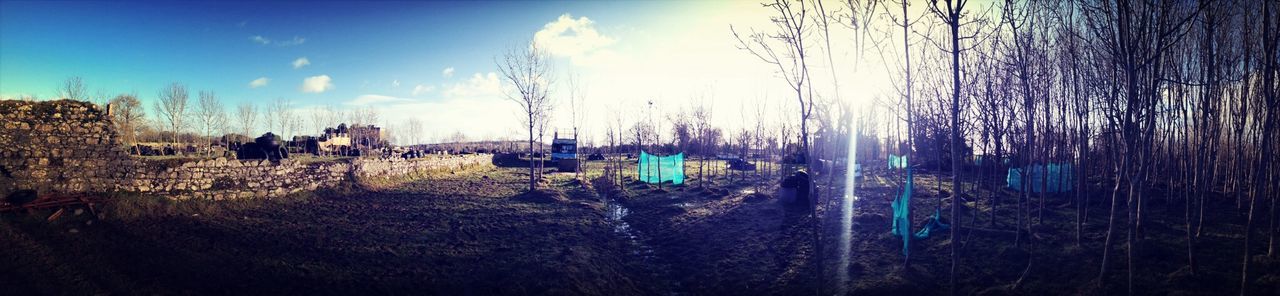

left=534, top=13, right=614, bottom=58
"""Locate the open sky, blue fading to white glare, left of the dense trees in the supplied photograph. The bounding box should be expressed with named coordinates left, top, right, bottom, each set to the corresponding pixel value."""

left=0, top=1, right=914, bottom=142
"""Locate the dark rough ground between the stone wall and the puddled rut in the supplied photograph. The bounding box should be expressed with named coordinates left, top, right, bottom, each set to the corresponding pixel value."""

left=0, top=165, right=655, bottom=295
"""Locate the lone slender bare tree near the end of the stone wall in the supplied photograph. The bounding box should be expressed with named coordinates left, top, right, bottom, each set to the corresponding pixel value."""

left=495, top=42, right=552, bottom=191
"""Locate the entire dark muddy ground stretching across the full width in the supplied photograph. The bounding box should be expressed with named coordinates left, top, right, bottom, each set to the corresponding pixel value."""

left=0, top=161, right=1280, bottom=295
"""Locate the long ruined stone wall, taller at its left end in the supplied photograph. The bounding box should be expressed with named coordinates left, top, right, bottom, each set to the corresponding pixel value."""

left=0, top=100, right=492, bottom=200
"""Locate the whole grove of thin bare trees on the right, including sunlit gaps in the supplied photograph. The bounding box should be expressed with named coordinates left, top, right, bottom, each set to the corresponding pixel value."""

left=732, top=0, right=1280, bottom=293
